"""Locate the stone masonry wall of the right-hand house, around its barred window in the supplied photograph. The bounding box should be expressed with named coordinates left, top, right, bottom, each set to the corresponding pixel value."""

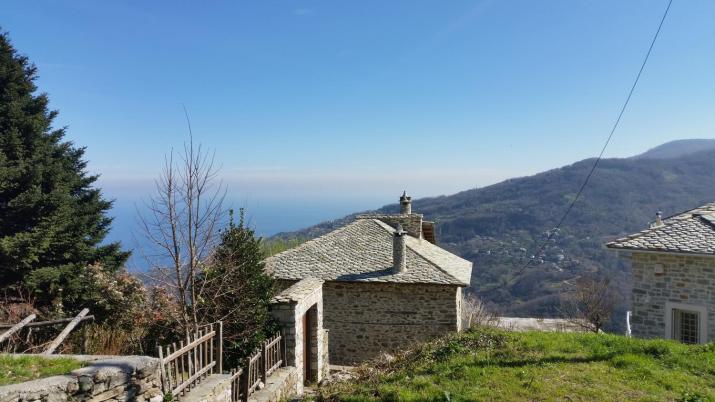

left=631, top=252, right=715, bottom=342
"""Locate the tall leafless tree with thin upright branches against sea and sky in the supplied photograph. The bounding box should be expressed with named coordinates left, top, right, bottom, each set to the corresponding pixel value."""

left=138, top=115, right=226, bottom=334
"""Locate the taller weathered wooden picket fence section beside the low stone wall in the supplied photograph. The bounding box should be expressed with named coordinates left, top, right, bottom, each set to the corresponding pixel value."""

left=158, top=322, right=223, bottom=397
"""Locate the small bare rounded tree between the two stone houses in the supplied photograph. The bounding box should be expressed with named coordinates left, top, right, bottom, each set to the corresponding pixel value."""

left=562, top=276, right=617, bottom=332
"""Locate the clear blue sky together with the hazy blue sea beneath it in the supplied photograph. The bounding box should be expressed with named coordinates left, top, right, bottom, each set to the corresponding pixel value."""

left=0, top=0, right=715, bottom=243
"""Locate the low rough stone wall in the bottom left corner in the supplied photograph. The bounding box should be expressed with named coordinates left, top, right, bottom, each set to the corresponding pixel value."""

left=0, top=355, right=163, bottom=402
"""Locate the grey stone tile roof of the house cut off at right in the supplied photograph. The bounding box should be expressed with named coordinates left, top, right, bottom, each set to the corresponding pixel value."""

left=606, top=202, right=715, bottom=255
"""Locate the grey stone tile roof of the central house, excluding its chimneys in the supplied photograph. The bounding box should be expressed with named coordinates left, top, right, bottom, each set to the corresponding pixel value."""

left=266, top=219, right=472, bottom=286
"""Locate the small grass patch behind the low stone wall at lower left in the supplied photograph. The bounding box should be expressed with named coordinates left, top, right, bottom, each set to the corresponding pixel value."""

left=0, top=355, right=84, bottom=386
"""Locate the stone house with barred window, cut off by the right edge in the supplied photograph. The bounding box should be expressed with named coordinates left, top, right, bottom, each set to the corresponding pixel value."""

left=606, top=203, right=715, bottom=343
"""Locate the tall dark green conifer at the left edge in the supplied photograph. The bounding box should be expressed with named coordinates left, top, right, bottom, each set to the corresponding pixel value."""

left=0, top=33, right=129, bottom=310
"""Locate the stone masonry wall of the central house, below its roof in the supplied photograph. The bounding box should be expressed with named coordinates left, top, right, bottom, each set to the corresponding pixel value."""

left=323, top=282, right=461, bottom=365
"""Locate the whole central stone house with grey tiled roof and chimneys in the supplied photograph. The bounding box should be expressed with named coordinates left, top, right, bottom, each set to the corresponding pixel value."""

left=266, top=194, right=472, bottom=365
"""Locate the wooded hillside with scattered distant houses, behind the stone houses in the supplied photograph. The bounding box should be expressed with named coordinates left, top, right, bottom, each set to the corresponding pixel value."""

left=279, top=140, right=715, bottom=329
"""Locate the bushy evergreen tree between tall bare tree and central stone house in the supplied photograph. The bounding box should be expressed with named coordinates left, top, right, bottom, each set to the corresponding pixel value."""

left=197, top=209, right=277, bottom=367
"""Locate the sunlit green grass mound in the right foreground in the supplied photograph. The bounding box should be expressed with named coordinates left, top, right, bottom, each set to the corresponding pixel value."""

left=318, top=329, right=715, bottom=401
